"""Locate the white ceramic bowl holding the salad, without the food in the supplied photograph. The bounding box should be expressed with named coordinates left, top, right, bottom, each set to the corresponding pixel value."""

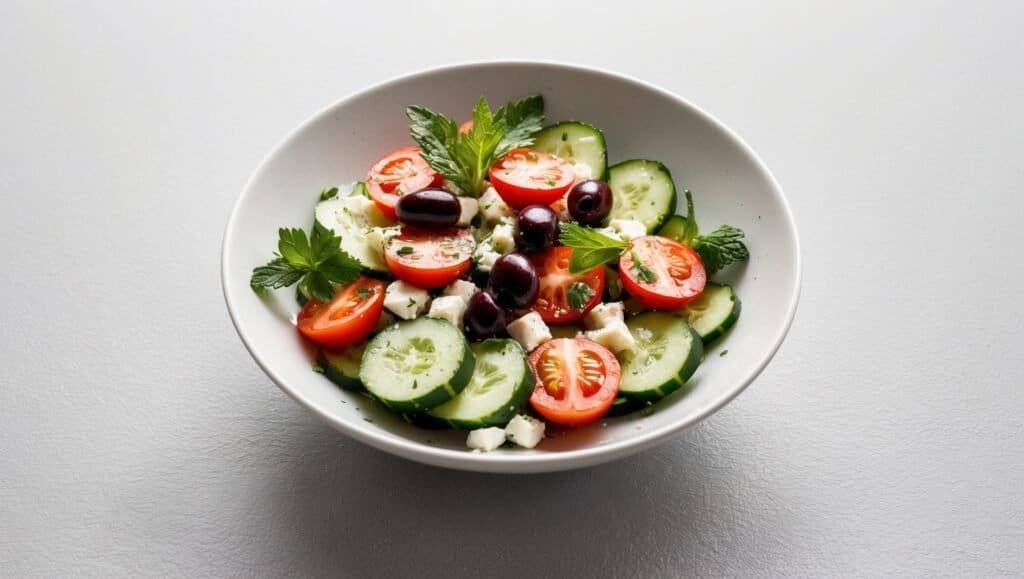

left=221, top=63, right=801, bottom=472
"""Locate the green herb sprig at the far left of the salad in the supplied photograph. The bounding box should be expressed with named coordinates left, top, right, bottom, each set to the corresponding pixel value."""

left=249, top=228, right=361, bottom=301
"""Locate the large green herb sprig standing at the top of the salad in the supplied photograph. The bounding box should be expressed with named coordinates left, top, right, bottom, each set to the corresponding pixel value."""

left=406, top=95, right=544, bottom=195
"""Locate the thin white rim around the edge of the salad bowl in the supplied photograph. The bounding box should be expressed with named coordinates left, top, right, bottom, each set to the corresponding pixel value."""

left=220, top=59, right=803, bottom=472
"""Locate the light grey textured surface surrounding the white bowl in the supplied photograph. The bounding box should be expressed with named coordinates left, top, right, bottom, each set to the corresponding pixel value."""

left=0, top=2, right=1024, bottom=577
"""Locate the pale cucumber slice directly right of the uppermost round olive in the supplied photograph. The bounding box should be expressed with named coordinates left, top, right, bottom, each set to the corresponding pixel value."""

left=608, top=159, right=676, bottom=234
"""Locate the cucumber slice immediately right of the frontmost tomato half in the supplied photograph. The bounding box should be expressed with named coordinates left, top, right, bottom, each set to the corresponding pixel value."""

left=618, top=312, right=703, bottom=400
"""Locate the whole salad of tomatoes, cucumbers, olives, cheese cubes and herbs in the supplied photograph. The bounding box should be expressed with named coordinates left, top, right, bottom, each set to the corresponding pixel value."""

left=251, top=95, right=749, bottom=451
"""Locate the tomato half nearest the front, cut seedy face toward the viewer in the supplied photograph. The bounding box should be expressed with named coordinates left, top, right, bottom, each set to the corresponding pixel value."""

left=529, top=338, right=622, bottom=426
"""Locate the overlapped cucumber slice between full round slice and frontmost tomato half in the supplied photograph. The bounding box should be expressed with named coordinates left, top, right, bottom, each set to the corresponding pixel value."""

left=427, top=339, right=537, bottom=428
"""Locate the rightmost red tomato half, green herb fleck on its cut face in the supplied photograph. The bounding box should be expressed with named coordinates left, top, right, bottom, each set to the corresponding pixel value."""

left=618, top=236, right=708, bottom=311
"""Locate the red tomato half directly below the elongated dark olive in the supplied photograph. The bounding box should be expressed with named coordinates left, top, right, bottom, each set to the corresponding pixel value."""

left=384, top=225, right=476, bottom=289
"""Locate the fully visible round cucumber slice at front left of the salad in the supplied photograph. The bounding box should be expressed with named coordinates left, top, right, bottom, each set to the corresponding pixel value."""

left=359, top=318, right=474, bottom=412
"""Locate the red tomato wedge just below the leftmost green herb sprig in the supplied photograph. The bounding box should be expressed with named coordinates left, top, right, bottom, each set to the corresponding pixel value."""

left=296, top=277, right=384, bottom=347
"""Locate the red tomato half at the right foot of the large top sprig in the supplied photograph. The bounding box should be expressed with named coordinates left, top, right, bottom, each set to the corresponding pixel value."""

left=489, top=149, right=575, bottom=209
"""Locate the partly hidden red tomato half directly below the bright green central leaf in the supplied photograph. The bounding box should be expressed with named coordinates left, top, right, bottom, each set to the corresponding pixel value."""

left=530, top=246, right=604, bottom=324
